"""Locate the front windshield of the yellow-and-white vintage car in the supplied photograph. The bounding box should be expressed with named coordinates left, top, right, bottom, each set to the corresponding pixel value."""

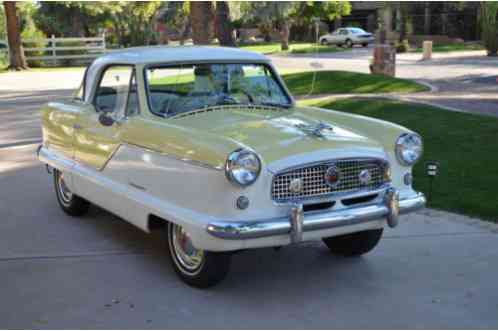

left=145, top=63, right=291, bottom=116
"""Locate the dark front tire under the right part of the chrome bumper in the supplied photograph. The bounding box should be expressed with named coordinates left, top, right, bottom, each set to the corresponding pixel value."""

left=322, top=229, right=384, bottom=256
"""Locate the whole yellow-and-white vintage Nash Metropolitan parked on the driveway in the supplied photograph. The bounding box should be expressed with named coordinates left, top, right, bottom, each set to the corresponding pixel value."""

left=37, top=47, right=425, bottom=287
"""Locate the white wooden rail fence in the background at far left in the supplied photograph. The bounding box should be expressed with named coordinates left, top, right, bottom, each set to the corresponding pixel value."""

left=0, top=35, right=107, bottom=64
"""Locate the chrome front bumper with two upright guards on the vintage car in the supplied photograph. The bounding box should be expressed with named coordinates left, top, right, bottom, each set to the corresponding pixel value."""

left=207, top=188, right=426, bottom=243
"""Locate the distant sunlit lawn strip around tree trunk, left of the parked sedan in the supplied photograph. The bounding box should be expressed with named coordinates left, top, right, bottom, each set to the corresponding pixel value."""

left=239, top=42, right=347, bottom=54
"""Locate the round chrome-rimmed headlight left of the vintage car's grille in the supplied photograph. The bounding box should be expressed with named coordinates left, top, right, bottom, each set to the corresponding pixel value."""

left=225, top=149, right=261, bottom=186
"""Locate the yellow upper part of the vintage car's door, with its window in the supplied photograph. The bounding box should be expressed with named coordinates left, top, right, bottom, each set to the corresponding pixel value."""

left=74, top=65, right=135, bottom=170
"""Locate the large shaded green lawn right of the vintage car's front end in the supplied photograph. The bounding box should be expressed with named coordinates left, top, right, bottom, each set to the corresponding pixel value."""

left=300, top=99, right=498, bottom=222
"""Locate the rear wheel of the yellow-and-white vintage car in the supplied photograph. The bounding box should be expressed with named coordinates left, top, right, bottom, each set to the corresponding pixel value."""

left=54, top=169, right=90, bottom=216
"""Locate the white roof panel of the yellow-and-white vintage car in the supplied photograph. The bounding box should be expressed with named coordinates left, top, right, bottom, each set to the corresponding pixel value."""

left=91, top=46, right=268, bottom=64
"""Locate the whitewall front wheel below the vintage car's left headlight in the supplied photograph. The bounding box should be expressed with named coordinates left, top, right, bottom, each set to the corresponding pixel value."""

left=167, top=222, right=231, bottom=288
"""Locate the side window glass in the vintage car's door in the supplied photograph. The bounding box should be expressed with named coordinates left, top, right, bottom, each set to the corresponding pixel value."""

left=95, top=66, right=133, bottom=117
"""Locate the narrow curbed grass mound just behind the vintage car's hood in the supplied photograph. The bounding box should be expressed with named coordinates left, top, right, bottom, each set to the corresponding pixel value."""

left=282, top=71, right=428, bottom=96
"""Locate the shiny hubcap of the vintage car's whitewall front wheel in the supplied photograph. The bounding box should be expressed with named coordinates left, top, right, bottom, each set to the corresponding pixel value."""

left=171, top=224, right=204, bottom=271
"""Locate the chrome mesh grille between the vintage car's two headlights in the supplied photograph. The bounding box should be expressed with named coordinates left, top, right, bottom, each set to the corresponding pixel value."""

left=271, top=159, right=388, bottom=202
